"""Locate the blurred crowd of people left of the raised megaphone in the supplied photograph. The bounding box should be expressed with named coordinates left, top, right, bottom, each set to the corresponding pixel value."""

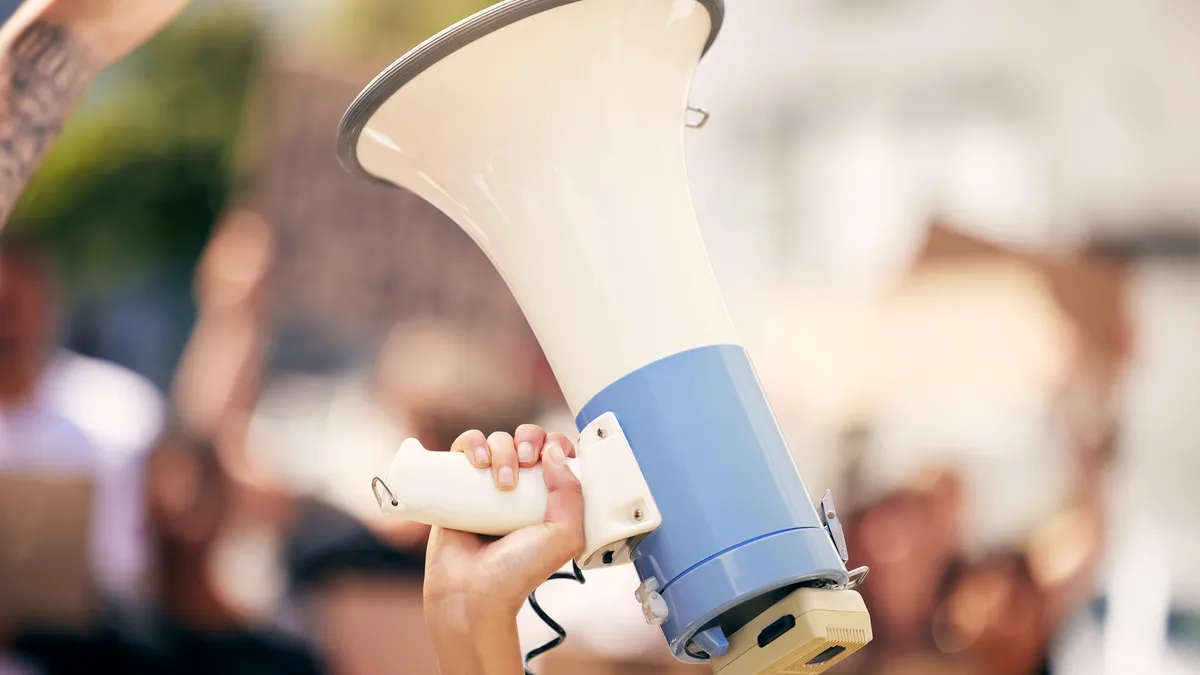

left=0, top=200, right=554, bottom=673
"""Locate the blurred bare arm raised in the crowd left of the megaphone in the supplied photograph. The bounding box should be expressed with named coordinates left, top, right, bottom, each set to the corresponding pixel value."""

left=172, top=203, right=294, bottom=613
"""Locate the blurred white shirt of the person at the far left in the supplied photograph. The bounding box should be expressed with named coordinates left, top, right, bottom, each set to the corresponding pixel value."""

left=0, top=351, right=166, bottom=593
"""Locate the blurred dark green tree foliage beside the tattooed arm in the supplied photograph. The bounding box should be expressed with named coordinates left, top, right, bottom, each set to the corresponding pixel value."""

left=10, top=5, right=263, bottom=288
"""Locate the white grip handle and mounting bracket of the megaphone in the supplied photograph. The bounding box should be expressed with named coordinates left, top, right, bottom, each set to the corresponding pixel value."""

left=372, top=413, right=662, bottom=569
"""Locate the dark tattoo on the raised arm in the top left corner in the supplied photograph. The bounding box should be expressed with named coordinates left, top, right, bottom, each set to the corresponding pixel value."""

left=0, top=20, right=98, bottom=223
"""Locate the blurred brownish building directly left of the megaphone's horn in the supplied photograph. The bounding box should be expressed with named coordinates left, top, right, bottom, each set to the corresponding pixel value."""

left=252, top=61, right=528, bottom=367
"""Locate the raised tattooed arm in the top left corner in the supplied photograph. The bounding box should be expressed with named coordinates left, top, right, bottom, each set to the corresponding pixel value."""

left=0, top=0, right=187, bottom=228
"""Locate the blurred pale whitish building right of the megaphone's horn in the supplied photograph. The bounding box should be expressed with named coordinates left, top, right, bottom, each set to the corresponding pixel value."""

left=689, top=0, right=1200, bottom=299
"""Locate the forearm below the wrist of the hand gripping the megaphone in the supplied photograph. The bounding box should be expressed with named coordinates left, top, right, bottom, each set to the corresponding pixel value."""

left=426, top=603, right=524, bottom=675
